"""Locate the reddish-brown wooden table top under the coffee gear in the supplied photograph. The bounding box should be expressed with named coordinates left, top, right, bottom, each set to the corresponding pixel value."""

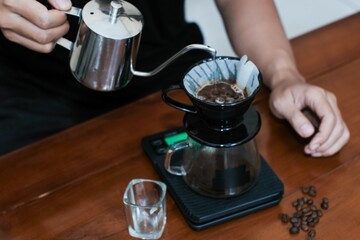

left=0, top=14, right=360, bottom=240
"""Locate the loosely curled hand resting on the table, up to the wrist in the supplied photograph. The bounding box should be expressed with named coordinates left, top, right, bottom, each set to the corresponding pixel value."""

left=270, top=75, right=350, bottom=157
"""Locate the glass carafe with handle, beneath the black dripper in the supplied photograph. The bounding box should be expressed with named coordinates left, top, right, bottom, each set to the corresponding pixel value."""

left=165, top=137, right=261, bottom=198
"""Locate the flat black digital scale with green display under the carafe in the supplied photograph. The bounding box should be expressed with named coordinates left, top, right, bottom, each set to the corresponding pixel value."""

left=141, top=128, right=284, bottom=230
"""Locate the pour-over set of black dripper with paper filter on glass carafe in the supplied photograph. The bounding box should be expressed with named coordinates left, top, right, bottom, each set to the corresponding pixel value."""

left=162, top=56, right=261, bottom=198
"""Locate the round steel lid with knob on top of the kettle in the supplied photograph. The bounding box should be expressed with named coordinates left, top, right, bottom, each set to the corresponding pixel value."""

left=82, top=0, right=143, bottom=40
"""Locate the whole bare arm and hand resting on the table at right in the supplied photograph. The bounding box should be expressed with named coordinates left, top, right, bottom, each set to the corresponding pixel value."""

left=216, top=0, right=350, bottom=157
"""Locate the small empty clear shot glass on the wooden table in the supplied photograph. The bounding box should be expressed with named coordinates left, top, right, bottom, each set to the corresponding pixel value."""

left=123, top=179, right=166, bottom=239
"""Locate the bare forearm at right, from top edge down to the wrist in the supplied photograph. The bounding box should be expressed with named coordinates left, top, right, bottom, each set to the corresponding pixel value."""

left=217, top=0, right=304, bottom=89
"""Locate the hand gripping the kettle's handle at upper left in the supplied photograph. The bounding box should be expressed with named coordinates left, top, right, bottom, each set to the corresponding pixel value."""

left=0, top=0, right=71, bottom=53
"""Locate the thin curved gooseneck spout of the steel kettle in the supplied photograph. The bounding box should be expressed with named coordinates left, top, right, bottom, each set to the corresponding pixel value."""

left=130, top=44, right=216, bottom=77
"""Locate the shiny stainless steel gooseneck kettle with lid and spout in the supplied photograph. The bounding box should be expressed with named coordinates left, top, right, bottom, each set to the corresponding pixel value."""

left=57, top=0, right=216, bottom=91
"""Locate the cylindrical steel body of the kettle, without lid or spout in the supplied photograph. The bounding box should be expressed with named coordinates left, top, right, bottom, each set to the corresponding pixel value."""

left=70, top=15, right=141, bottom=91
